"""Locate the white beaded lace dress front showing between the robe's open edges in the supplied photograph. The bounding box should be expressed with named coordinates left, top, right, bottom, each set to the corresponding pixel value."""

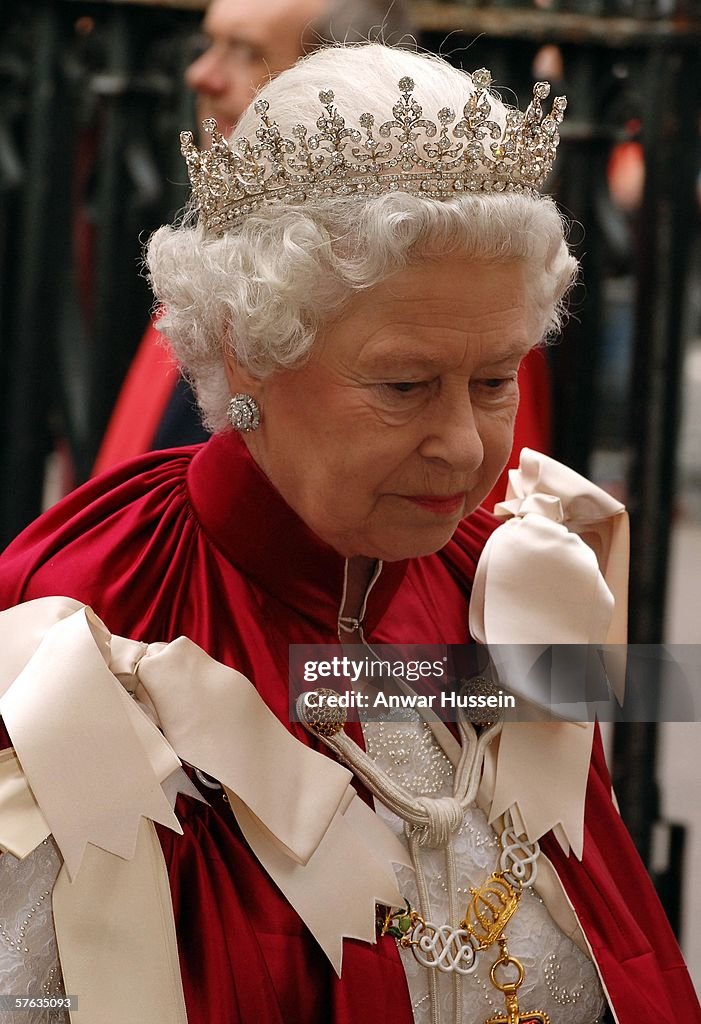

left=363, top=712, right=606, bottom=1024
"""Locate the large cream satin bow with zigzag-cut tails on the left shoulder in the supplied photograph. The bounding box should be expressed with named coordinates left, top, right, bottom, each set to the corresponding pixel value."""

left=0, top=598, right=406, bottom=1024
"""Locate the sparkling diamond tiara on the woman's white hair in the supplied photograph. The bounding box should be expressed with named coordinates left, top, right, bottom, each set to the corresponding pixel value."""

left=180, top=69, right=567, bottom=234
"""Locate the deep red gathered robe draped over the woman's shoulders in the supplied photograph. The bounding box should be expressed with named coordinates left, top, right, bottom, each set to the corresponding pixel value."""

left=0, top=434, right=699, bottom=1024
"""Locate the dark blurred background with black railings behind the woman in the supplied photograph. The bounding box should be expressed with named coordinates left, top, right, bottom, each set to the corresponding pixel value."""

left=0, top=0, right=701, bottom=991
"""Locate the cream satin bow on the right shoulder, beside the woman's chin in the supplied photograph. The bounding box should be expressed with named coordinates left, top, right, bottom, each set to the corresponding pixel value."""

left=470, top=449, right=628, bottom=859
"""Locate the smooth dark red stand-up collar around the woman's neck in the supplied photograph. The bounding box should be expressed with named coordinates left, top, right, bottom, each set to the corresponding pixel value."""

left=187, top=431, right=409, bottom=634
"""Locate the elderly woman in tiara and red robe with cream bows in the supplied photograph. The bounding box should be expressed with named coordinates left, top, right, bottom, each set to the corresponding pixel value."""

left=0, top=45, right=697, bottom=1024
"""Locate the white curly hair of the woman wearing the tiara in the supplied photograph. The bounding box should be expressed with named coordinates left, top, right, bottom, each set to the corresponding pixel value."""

left=146, top=43, right=577, bottom=431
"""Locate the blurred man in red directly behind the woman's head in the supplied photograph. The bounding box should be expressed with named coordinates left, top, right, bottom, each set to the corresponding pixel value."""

left=94, top=0, right=414, bottom=473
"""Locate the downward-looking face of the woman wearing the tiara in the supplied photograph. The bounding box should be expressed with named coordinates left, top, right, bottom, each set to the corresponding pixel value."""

left=228, top=256, right=537, bottom=561
